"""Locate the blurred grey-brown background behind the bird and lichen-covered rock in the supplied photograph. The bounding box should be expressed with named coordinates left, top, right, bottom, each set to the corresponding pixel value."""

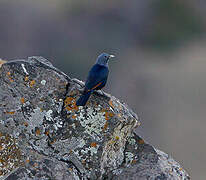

left=0, top=0, right=206, bottom=180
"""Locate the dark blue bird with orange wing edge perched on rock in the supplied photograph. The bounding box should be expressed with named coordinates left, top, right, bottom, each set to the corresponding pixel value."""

left=76, top=53, right=114, bottom=106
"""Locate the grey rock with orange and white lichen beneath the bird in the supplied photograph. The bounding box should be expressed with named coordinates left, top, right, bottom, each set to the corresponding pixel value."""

left=0, top=57, right=190, bottom=180
